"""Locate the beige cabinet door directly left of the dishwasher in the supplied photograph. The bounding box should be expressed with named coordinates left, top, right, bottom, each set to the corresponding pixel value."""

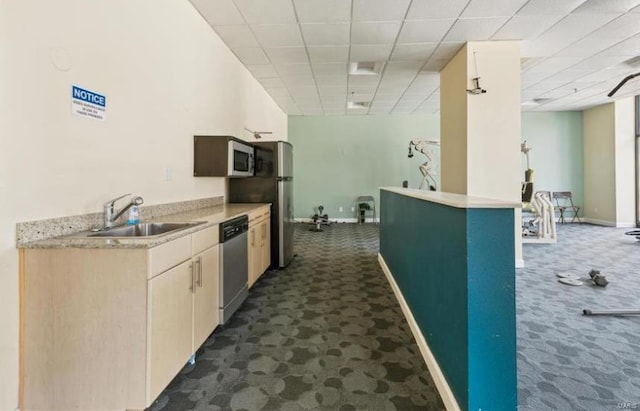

left=193, top=245, right=220, bottom=352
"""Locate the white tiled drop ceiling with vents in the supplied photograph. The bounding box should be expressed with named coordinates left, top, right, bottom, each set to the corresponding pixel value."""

left=190, top=0, right=640, bottom=115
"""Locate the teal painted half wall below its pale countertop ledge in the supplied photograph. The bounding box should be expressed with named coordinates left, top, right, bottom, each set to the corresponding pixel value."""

left=380, top=190, right=517, bottom=411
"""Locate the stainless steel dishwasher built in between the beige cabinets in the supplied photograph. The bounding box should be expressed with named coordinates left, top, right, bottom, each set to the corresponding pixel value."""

left=219, top=215, right=249, bottom=324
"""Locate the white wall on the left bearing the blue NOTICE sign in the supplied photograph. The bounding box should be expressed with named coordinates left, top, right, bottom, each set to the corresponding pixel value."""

left=0, top=0, right=287, bottom=410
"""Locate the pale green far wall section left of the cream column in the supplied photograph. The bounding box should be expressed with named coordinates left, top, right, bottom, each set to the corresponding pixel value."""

left=288, top=115, right=440, bottom=220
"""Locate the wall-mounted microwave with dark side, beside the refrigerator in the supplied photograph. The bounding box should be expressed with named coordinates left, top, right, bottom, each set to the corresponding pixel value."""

left=193, top=136, right=255, bottom=177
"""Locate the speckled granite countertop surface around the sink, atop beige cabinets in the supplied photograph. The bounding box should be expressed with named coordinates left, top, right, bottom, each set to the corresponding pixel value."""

left=20, top=203, right=270, bottom=248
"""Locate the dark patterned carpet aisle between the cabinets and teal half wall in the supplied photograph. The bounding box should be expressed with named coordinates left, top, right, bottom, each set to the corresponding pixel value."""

left=150, top=224, right=444, bottom=411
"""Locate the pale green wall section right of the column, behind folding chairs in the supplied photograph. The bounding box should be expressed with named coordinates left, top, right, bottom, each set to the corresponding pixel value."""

left=522, top=111, right=584, bottom=212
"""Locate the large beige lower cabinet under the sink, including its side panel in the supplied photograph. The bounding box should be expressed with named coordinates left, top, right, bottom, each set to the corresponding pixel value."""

left=20, top=225, right=219, bottom=410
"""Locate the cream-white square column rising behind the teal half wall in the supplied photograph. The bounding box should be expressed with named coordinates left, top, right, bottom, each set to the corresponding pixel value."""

left=440, top=41, right=524, bottom=265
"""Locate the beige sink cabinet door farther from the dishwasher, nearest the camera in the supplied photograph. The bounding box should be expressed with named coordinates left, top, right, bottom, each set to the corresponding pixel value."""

left=148, top=261, right=193, bottom=399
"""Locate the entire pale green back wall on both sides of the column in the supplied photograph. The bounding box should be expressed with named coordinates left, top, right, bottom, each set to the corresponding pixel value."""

left=288, top=112, right=583, bottom=220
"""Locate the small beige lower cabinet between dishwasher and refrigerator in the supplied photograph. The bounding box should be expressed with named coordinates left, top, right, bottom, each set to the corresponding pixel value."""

left=247, top=207, right=271, bottom=287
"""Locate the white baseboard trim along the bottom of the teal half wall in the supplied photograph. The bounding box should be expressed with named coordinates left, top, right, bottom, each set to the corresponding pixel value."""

left=378, top=253, right=460, bottom=411
